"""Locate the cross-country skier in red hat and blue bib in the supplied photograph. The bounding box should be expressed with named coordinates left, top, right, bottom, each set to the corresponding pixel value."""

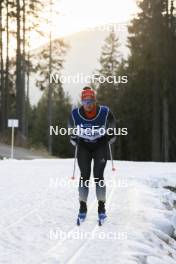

left=69, top=87, right=116, bottom=224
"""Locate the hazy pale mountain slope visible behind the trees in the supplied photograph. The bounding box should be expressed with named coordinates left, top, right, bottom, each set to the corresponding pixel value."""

left=30, top=25, right=129, bottom=104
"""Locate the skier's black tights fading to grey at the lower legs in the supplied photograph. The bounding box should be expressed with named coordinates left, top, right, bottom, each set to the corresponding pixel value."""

left=77, top=139, right=108, bottom=202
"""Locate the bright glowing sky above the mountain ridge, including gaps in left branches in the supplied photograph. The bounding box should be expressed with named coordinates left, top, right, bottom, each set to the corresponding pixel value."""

left=32, top=0, right=137, bottom=46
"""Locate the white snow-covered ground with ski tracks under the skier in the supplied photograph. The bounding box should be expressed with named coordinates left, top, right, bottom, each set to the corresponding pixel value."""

left=0, top=159, right=176, bottom=264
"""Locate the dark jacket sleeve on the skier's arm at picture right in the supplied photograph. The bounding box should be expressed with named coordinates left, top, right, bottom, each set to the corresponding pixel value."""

left=106, top=110, right=117, bottom=144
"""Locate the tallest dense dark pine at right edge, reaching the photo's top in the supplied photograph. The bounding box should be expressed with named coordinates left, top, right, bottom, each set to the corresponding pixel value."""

left=126, top=0, right=175, bottom=161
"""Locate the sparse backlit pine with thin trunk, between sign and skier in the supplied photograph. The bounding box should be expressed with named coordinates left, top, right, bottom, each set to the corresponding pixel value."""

left=31, top=39, right=70, bottom=154
